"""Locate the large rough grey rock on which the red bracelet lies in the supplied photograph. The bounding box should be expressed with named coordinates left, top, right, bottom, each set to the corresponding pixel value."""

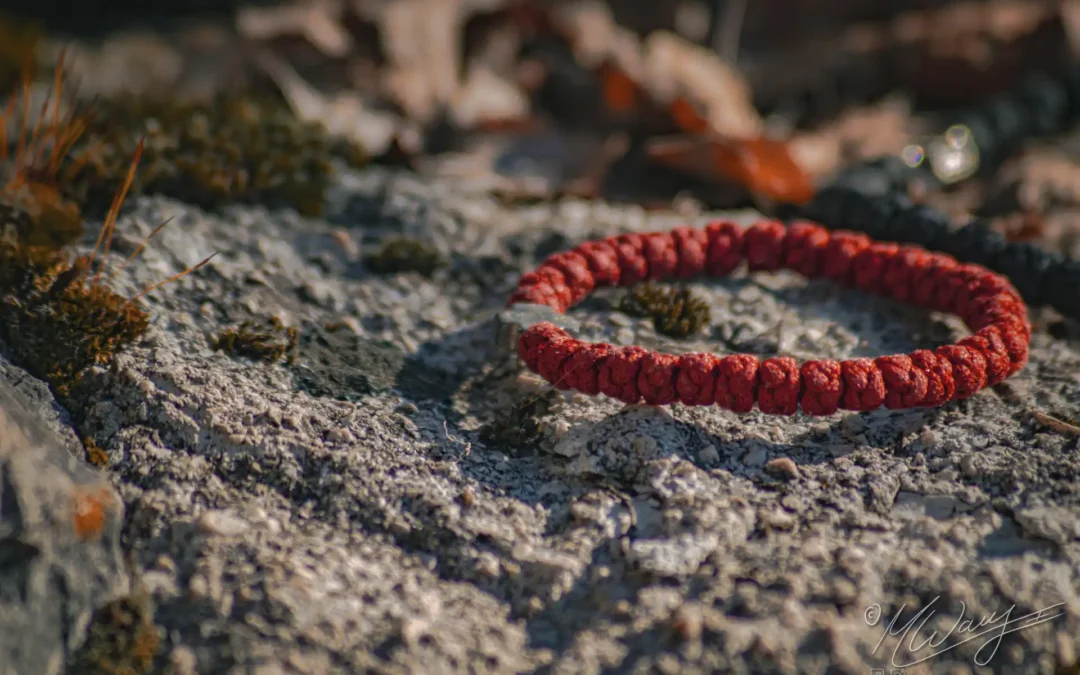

left=8, top=164, right=1080, bottom=674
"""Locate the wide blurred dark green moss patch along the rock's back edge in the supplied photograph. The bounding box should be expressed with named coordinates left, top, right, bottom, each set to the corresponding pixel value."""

left=52, top=94, right=366, bottom=215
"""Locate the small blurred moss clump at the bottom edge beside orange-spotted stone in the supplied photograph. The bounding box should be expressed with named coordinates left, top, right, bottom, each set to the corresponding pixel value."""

left=73, top=592, right=161, bottom=675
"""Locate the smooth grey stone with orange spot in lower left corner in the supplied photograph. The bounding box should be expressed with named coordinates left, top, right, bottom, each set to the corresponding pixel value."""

left=0, top=356, right=127, bottom=675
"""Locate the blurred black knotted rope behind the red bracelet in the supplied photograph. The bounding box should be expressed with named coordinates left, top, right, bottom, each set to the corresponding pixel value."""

left=801, top=64, right=1080, bottom=321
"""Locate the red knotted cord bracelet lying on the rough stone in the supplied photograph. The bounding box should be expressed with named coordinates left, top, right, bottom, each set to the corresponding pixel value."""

left=510, top=220, right=1031, bottom=415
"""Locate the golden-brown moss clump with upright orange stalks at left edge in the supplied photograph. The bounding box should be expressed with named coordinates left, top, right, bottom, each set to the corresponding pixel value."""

left=0, top=59, right=205, bottom=400
